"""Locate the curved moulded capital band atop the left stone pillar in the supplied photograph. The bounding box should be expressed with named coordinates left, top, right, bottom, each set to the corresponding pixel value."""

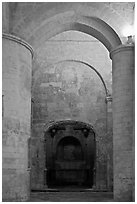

left=2, top=33, right=34, bottom=58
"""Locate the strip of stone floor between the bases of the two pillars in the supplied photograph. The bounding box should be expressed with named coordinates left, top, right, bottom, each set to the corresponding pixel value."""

left=29, top=192, right=113, bottom=202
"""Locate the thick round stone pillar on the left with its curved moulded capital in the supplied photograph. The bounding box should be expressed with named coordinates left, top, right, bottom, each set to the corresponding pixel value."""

left=2, top=34, right=33, bottom=202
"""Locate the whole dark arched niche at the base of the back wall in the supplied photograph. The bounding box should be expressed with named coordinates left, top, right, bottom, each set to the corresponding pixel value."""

left=45, top=121, right=96, bottom=188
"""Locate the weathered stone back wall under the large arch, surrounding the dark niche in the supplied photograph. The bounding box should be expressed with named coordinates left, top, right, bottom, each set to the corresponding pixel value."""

left=31, top=32, right=112, bottom=189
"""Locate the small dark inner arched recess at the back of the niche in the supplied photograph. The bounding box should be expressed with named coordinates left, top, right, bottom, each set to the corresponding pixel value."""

left=55, top=136, right=85, bottom=185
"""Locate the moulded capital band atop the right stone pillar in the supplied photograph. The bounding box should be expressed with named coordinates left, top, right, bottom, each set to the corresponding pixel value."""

left=109, top=44, right=135, bottom=59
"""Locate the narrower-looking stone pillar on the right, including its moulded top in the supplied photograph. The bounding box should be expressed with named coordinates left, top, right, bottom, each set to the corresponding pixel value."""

left=110, top=45, right=134, bottom=202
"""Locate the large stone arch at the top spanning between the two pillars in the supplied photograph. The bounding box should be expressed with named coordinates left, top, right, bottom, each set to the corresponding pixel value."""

left=29, top=12, right=121, bottom=52
